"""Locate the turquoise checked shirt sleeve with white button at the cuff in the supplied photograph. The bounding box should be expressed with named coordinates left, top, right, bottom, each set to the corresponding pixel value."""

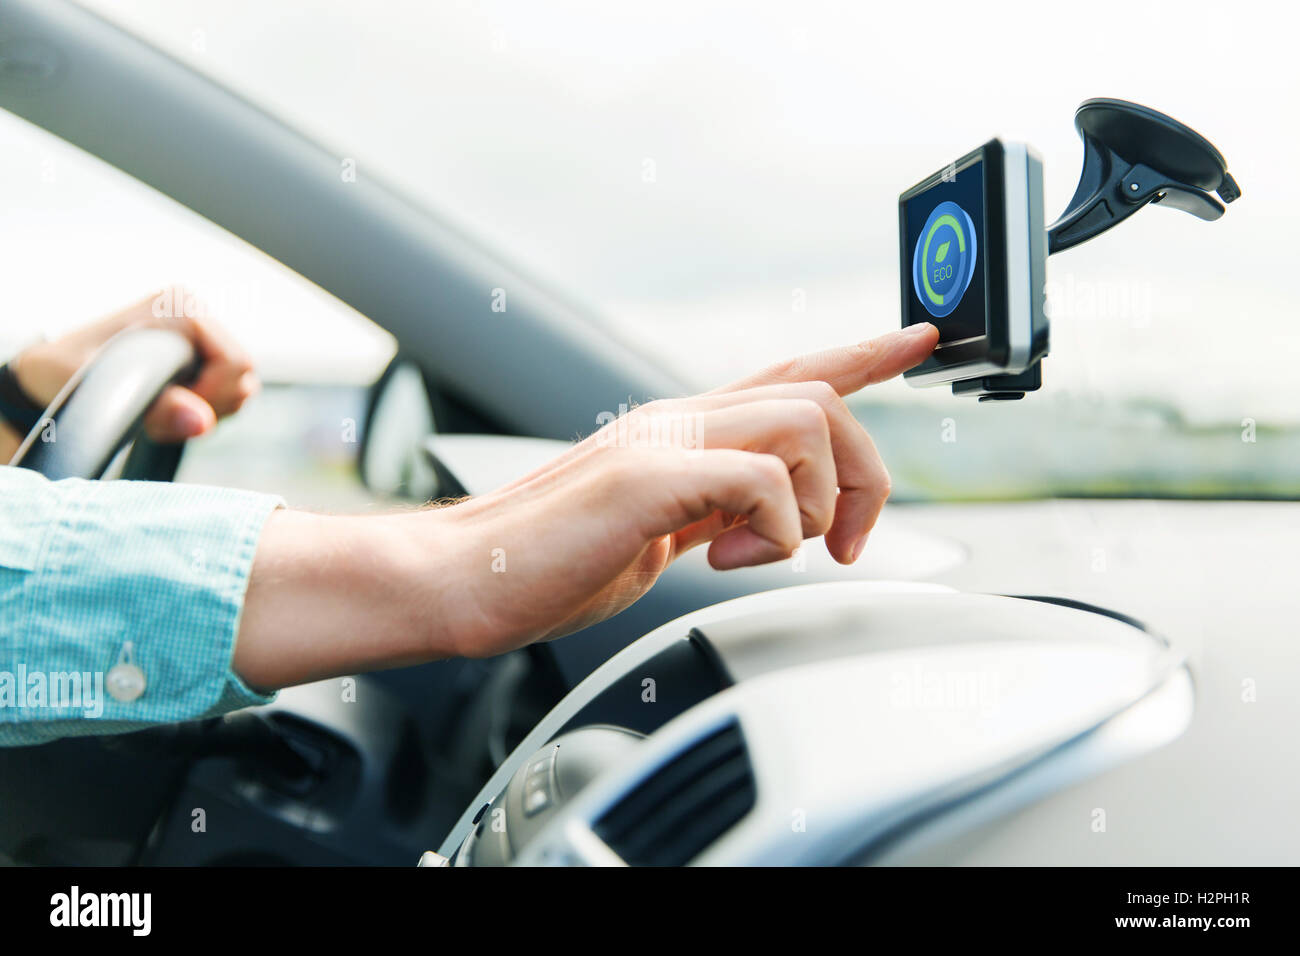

left=0, top=479, right=285, bottom=744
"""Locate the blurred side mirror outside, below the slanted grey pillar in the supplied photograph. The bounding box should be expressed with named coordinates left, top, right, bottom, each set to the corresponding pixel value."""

left=358, top=352, right=452, bottom=501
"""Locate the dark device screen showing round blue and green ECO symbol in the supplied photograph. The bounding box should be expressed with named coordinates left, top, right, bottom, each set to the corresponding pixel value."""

left=904, top=160, right=988, bottom=342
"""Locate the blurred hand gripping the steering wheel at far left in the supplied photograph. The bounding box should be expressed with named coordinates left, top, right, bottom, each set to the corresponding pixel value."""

left=5, top=293, right=260, bottom=444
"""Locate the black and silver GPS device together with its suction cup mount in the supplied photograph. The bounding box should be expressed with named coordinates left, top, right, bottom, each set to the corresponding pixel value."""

left=898, top=99, right=1242, bottom=401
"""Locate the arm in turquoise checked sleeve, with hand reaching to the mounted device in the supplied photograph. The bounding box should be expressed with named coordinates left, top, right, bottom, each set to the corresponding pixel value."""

left=0, top=325, right=937, bottom=745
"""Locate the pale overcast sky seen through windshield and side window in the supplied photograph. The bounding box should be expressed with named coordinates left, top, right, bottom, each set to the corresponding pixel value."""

left=0, top=0, right=1300, bottom=420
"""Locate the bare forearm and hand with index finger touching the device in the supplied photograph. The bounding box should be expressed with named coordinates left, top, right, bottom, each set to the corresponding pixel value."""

left=234, top=325, right=937, bottom=688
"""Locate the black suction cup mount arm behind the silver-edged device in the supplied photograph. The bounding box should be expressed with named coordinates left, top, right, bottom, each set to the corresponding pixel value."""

left=1048, top=99, right=1242, bottom=255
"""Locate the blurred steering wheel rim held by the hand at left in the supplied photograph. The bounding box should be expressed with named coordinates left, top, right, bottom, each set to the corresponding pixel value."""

left=9, top=329, right=199, bottom=481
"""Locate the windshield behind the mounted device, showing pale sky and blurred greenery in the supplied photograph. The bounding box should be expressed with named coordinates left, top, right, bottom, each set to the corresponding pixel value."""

left=73, top=0, right=1300, bottom=498
